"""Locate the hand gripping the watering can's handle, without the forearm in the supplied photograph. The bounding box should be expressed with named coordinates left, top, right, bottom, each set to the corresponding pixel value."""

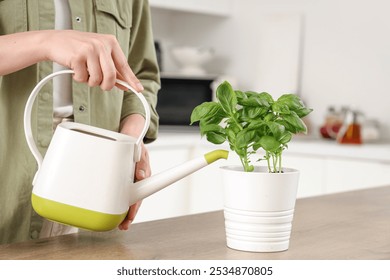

left=47, top=30, right=143, bottom=91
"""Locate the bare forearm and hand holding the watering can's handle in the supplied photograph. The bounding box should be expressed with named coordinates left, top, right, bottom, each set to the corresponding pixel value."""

left=0, top=30, right=143, bottom=91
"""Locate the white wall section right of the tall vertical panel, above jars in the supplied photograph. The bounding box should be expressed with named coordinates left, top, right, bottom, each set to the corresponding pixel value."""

left=302, top=0, right=390, bottom=138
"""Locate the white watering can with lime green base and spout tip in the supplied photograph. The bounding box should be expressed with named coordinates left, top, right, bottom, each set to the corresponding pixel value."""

left=24, top=70, right=228, bottom=231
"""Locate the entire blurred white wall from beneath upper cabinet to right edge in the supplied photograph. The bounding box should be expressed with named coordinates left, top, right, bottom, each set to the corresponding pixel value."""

left=153, top=0, right=390, bottom=139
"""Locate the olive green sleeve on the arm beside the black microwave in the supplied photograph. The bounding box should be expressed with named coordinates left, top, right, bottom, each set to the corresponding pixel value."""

left=121, top=0, right=161, bottom=143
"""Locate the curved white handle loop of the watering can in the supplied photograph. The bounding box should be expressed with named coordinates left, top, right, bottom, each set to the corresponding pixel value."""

left=24, top=70, right=150, bottom=169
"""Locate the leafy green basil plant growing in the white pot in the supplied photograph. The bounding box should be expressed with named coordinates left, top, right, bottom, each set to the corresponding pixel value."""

left=191, top=81, right=312, bottom=173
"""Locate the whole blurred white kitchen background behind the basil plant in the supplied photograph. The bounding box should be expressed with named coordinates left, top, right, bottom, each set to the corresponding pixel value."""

left=133, top=0, right=390, bottom=223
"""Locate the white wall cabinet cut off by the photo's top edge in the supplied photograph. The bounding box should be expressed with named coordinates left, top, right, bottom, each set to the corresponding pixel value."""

left=149, top=0, right=232, bottom=16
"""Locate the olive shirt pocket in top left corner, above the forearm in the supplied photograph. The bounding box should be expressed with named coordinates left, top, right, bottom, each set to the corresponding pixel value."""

left=0, top=0, right=27, bottom=35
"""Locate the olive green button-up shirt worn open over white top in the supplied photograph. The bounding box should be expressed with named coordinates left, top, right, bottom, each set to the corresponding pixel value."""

left=0, top=0, right=160, bottom=243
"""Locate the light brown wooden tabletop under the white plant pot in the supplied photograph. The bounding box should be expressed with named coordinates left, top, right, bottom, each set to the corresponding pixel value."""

left=0, top=186, right=390, bottom=260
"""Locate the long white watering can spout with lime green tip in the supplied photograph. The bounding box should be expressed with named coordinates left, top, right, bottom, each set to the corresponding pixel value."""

left=129, top=150, right=229, bottom=205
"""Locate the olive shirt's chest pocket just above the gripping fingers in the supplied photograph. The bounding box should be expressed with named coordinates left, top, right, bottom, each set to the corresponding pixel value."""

left=95, top=0, right=133, bottom=56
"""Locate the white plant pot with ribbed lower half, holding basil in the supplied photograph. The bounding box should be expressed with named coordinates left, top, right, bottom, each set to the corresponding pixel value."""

left=221, top=166, right=299, bottom=252
